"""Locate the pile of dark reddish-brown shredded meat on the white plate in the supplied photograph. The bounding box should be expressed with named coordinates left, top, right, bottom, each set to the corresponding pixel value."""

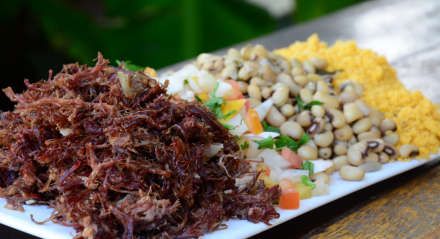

left=0, top=54, right=280, bottom=239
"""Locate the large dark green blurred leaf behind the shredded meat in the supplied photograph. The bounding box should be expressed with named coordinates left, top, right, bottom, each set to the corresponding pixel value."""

left=3, top=0, right=276, bottom=68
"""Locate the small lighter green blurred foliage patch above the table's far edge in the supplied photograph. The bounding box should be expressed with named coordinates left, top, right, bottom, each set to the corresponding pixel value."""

left=293, top=0, right=363, bottom=23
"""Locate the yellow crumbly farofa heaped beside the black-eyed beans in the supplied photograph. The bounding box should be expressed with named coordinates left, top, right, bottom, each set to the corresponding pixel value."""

left=275, top=34, right=440, bottom=161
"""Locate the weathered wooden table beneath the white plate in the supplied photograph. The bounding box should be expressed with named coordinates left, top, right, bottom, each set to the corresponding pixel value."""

left=0, top=0, right=440, bottom=239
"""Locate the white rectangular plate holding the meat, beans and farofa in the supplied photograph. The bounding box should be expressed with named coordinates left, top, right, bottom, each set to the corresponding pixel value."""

left=0, top=153, right=440, bottom=239
